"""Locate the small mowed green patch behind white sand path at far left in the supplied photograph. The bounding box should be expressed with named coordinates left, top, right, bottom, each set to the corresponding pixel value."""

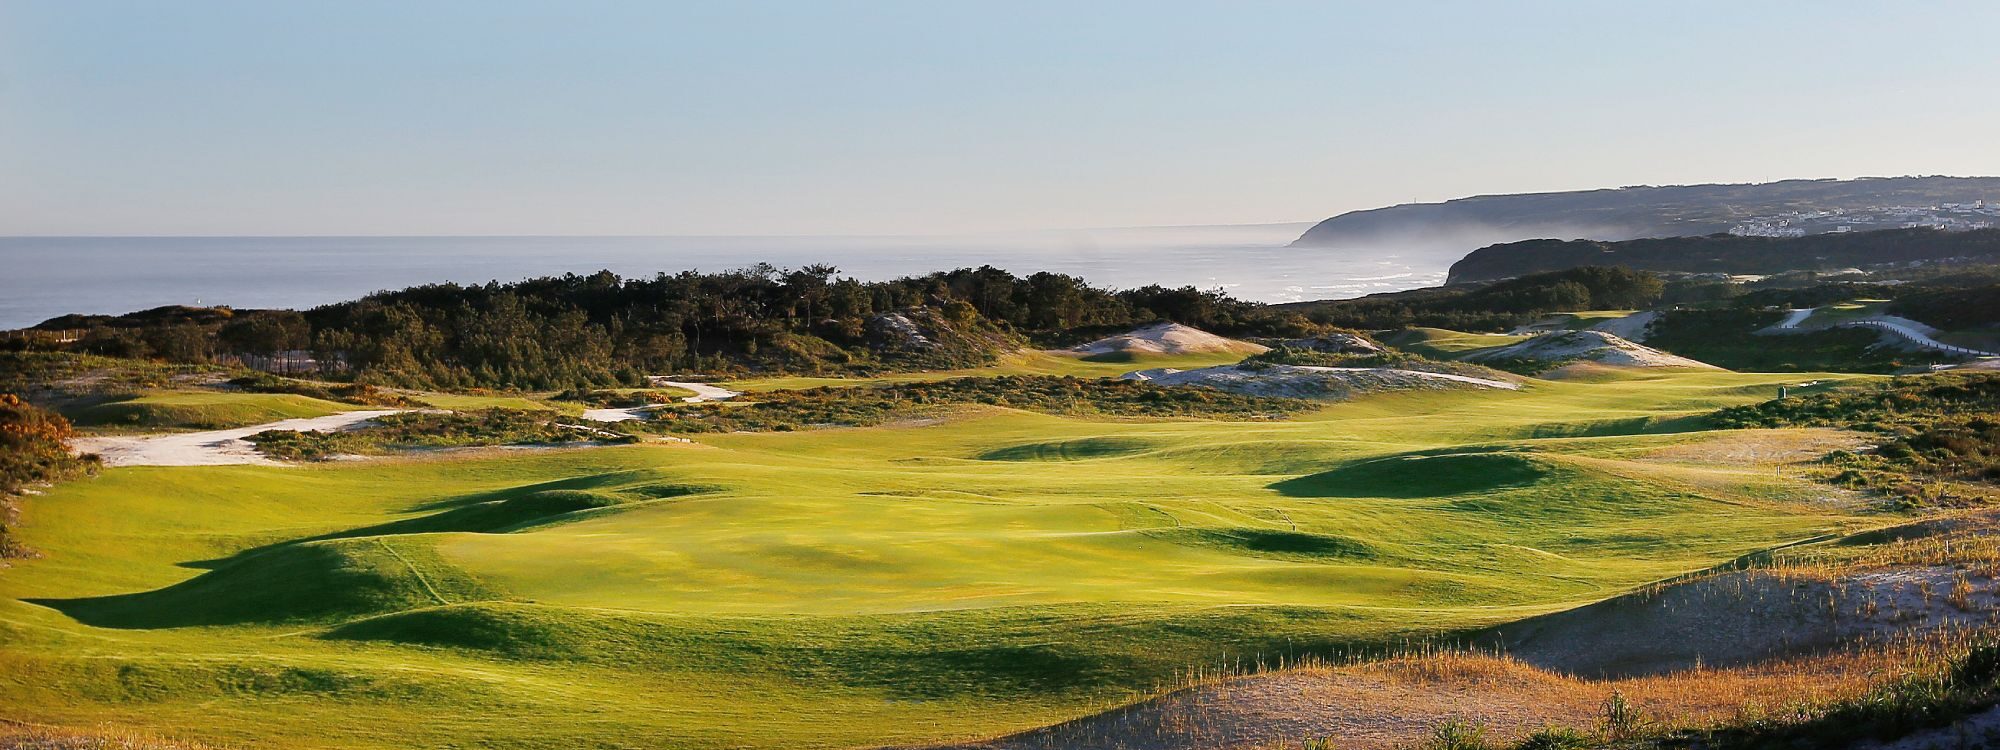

left=64, top=390, right=360, bottom=430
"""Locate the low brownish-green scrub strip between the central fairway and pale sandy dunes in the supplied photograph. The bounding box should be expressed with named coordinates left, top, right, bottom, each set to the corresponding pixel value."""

left=644, top=376, right=1318, bottom=432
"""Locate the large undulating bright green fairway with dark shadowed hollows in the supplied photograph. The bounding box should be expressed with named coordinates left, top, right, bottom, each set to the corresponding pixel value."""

left=0, top=372, right=1874, bottom=748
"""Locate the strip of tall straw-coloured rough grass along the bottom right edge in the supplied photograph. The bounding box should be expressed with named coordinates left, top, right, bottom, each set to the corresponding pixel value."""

left=966, top=638, right=1992, bottom=750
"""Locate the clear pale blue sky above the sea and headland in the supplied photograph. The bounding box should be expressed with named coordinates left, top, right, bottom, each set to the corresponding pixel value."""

left=0, top=0, right=2000, bottom=234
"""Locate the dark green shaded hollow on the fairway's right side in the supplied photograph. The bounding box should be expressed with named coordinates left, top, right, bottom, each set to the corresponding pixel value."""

left=1270, top=452, right=1554, bottom=500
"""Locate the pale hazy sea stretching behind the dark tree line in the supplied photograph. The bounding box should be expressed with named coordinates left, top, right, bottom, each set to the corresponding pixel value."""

left=0, top=222, right=1472, bottom=328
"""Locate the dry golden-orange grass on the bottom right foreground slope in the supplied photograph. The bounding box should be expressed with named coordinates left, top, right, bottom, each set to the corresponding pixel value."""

left=990, top=632, right=1974, bottom=750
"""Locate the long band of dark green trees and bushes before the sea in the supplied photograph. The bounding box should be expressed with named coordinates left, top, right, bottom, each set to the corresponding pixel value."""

left=27, top=264, right=1314, bottom=390
